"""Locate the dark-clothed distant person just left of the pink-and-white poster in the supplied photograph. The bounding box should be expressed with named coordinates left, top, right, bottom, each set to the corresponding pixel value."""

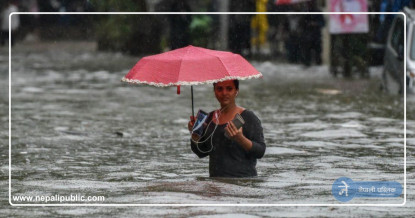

left=299, top=1, right=326, bottom=66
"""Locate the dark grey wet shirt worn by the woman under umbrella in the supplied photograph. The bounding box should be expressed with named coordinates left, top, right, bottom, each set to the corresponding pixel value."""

left=191, top=110, right=266, bottom=177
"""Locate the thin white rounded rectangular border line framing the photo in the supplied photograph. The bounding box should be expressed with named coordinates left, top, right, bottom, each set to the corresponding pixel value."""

left=9, top=12, right=406, bottom=207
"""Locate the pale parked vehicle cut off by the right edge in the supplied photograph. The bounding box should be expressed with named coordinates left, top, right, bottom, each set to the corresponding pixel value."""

left=382, top=8, right=415, bottom=94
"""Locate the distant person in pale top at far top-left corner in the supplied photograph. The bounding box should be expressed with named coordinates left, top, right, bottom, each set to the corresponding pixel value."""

left=0, top=1, right=20, bottom=46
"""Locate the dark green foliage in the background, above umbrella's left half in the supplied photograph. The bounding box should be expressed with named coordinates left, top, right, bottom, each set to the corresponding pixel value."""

left=91, top=0, right=161, bottom=55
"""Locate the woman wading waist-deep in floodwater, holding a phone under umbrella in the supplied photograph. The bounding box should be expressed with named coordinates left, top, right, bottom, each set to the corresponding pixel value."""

left=188, top=80, right=266, bottom=177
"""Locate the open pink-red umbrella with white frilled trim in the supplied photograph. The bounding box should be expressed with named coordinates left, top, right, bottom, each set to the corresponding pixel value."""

left=122, top=45, right=262, bottom=115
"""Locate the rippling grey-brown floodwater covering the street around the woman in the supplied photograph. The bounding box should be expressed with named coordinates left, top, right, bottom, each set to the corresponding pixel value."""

left=0, top=42, right=415, bottom=216
